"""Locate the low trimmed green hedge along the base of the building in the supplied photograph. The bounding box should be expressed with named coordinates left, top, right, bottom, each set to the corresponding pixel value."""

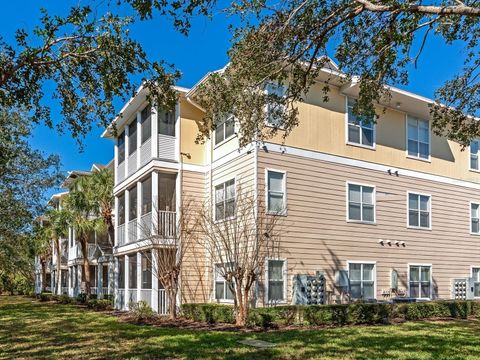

left=182, top=300, right=480, bottom=328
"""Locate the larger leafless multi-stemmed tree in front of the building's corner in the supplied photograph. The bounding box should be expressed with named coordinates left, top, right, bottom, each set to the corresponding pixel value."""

left=198, top=188, right=281, bottom=326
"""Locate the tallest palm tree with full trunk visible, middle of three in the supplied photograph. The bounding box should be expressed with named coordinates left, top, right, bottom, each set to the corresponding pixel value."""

left=65, top=176, right=105, bottom=297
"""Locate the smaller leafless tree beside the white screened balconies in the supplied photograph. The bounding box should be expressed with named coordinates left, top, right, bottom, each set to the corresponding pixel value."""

left=139, top=198, right=201, bottom=319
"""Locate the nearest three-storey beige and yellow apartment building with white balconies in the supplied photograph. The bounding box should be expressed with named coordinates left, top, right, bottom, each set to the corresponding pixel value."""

left=103, top=58, right=480, bottom=312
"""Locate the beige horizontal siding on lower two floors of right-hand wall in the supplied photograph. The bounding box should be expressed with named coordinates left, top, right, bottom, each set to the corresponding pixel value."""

left=258, top=151, right=480, bottom=299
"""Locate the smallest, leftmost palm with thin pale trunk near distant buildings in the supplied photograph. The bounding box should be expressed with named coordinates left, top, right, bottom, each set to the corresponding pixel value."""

left=47, top=209, right=70, bottom=295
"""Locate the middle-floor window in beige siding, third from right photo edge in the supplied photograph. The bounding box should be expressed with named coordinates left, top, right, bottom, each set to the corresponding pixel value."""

left=348, top=184, right=375, bottom=223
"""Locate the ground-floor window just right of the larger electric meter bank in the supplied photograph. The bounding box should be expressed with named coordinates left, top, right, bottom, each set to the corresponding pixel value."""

left=348, top=263, right=375, bottom=299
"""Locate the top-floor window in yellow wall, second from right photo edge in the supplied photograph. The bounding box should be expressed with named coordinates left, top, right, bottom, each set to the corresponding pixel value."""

left=407, top=116, right=430, bottom=160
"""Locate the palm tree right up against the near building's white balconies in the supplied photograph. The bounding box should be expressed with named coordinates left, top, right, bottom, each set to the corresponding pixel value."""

left=86, top=169, right=115, bottom=247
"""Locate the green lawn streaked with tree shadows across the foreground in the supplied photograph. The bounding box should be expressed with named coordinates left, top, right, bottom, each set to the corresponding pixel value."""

left=0, top=296, right=480, bottom=359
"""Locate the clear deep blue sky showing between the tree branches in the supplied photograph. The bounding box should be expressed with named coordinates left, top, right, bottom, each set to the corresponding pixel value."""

left=0, top=0, right=463, bottom=194
